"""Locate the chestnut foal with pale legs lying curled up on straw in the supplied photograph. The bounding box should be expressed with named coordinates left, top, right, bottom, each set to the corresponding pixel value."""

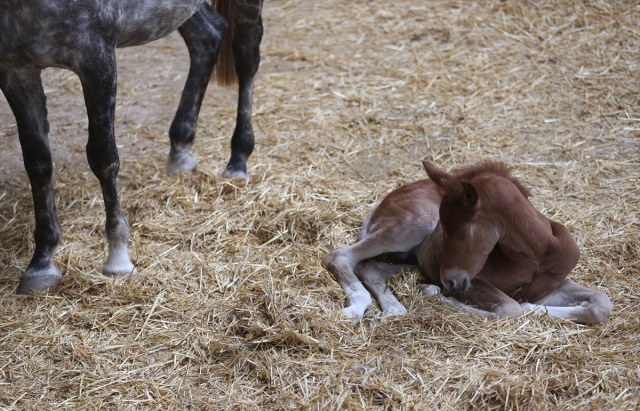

left=322, top=162, right=611, bottom=324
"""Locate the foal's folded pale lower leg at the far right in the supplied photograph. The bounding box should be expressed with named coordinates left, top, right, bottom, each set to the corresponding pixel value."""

left=522, top=280, right=612, bottom=324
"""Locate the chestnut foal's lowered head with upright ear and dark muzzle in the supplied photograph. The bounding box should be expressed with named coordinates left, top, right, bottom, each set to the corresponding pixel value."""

left=423, top=161, right=529, bottom=292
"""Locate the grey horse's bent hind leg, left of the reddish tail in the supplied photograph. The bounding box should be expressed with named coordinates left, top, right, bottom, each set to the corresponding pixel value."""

left=167, top=3, right=227, bottom=174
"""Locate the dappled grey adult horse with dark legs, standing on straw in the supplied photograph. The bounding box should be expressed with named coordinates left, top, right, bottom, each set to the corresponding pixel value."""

left=0, top=0, right=263, bottom=293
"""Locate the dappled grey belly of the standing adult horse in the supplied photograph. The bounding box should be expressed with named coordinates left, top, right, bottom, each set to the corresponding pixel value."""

left=0, top=0, right=204, bottom=68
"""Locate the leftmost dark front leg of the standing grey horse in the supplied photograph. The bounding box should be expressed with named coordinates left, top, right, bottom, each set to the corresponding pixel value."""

left=0, top=68, right=61, bottom=294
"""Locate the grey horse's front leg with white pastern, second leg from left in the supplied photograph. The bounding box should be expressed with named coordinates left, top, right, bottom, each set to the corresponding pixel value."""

left=77, top=44, right=135, bottom=277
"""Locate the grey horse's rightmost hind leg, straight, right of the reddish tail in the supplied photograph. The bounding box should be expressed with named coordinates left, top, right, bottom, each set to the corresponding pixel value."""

left=226, top=0, right=263, bottom=179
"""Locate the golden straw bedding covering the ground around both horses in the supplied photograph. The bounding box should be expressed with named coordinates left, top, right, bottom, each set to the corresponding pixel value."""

left=0, top=0, right=640, bottom=410
